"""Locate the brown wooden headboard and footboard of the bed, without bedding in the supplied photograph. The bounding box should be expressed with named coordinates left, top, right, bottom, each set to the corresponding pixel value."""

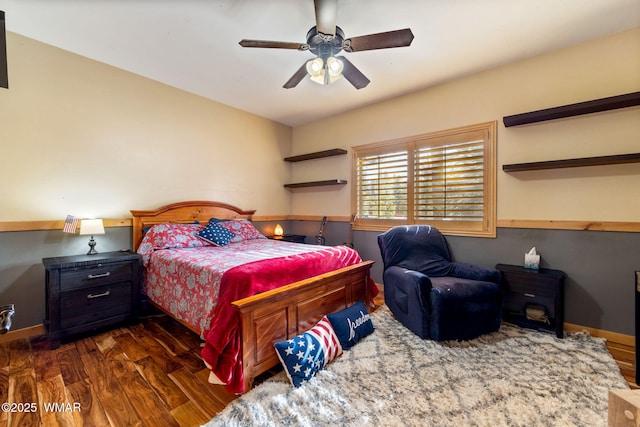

left=131, top=201, right=373, bottom=391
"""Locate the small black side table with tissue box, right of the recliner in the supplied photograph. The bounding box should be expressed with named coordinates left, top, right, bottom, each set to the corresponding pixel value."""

left=496, top=264, right=567, bottom=338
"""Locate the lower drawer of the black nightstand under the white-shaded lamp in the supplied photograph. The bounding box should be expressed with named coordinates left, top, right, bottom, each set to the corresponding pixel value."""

left=60, top=282, right=131, bottom=328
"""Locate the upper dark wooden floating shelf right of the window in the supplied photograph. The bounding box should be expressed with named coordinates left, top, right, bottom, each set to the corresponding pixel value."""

left=502, top=92, right=640, bottom=127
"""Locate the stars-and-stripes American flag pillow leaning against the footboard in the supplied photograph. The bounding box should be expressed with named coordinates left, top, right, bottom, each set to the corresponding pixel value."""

left=274, top=316, right=342, bottom=387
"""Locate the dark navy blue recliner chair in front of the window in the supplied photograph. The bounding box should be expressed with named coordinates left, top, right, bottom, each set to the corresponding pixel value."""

left=378, top=225, right=502, bottom=341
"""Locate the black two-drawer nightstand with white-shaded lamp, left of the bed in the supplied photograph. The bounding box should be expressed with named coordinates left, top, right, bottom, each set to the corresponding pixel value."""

left=42, top=251, right=141, bottom=348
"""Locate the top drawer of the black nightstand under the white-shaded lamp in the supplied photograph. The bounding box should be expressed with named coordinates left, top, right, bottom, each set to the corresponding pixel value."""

left=60, top=262, right=131, bottom=291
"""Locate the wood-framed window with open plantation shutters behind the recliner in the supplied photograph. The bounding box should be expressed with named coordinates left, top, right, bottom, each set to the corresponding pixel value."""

left=352, top=122, right=496, bottom=237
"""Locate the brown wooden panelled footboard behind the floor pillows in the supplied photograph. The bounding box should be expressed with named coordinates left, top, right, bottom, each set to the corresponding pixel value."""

left=232, top=261, right=373, bottom=391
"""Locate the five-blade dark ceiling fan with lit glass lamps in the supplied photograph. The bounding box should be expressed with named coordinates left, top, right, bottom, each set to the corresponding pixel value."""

left=240, top=0, right=413, bottom=89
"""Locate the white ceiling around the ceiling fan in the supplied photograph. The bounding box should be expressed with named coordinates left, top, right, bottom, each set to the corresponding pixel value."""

left=0, top=0, right=640, bottom=126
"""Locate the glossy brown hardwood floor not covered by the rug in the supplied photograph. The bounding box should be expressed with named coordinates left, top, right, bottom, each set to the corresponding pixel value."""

left=0, top=301, right=635, bottom=427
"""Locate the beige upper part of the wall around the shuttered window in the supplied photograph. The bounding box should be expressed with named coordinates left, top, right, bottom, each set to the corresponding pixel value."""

left=291, top=28, right=640, bottom=222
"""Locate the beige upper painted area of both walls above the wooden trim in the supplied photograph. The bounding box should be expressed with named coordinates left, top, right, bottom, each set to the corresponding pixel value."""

left=0, top=29, right=640, bottom=221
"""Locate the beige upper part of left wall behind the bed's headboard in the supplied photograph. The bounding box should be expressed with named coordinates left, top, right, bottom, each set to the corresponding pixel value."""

left=0, top=33, right=291, bottom=221
